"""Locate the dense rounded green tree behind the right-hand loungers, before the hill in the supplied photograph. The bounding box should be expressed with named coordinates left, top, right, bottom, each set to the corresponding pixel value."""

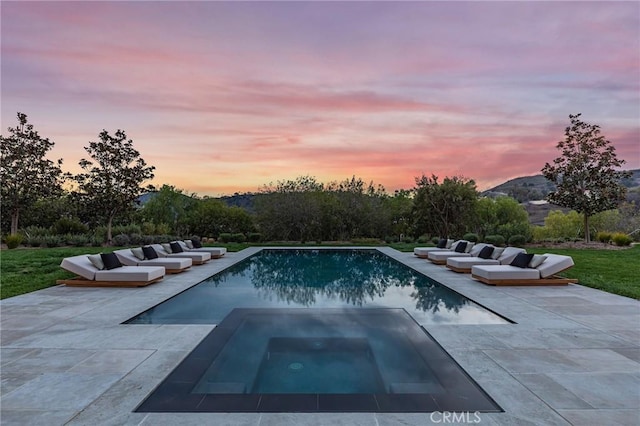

left=413, top=175, right=478, bottom=237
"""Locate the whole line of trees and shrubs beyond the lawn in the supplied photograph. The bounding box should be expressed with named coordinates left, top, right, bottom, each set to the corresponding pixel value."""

left=0, top=113, right=640, bottom=246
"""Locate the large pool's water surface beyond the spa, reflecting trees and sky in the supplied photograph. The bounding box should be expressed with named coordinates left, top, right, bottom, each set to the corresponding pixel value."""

left=131, top=250, right=506, bottom=325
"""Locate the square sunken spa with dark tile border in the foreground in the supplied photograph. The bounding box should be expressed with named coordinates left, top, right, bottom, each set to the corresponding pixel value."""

left=136, top=308, right=501, bottom=412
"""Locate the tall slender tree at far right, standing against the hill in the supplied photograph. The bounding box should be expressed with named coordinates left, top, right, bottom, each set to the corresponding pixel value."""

left=542, top=114, right=629, bottom=243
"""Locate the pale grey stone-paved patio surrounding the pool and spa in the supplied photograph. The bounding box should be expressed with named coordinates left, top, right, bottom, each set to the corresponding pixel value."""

left=0, top=248, right=640, bottom=426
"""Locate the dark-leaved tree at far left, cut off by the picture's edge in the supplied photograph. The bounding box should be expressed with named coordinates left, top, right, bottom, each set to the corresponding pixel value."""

left=0, top=112, right=65, bottom=234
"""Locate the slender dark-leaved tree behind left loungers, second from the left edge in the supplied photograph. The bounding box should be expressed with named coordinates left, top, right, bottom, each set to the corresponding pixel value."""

left=74, top=129, right=155, bottom=244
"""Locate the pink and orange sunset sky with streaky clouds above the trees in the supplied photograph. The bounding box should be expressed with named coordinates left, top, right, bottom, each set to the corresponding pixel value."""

left=0, top=1, right=640, bottom=196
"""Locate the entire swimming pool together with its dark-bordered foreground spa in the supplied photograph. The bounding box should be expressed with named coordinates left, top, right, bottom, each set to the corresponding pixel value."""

left=132, top=249, right=509, bottom=412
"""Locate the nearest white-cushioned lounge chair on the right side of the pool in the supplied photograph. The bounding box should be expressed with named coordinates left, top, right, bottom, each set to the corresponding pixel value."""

left=471, top=253, right=578, bottom=286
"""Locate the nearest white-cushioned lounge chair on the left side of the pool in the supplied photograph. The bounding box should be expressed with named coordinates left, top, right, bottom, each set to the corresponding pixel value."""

left=56, top=255, right=165, bottom=287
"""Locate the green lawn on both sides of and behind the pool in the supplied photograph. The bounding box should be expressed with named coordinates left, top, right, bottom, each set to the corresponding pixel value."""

left=0, top=242, right=640, bottom=299
